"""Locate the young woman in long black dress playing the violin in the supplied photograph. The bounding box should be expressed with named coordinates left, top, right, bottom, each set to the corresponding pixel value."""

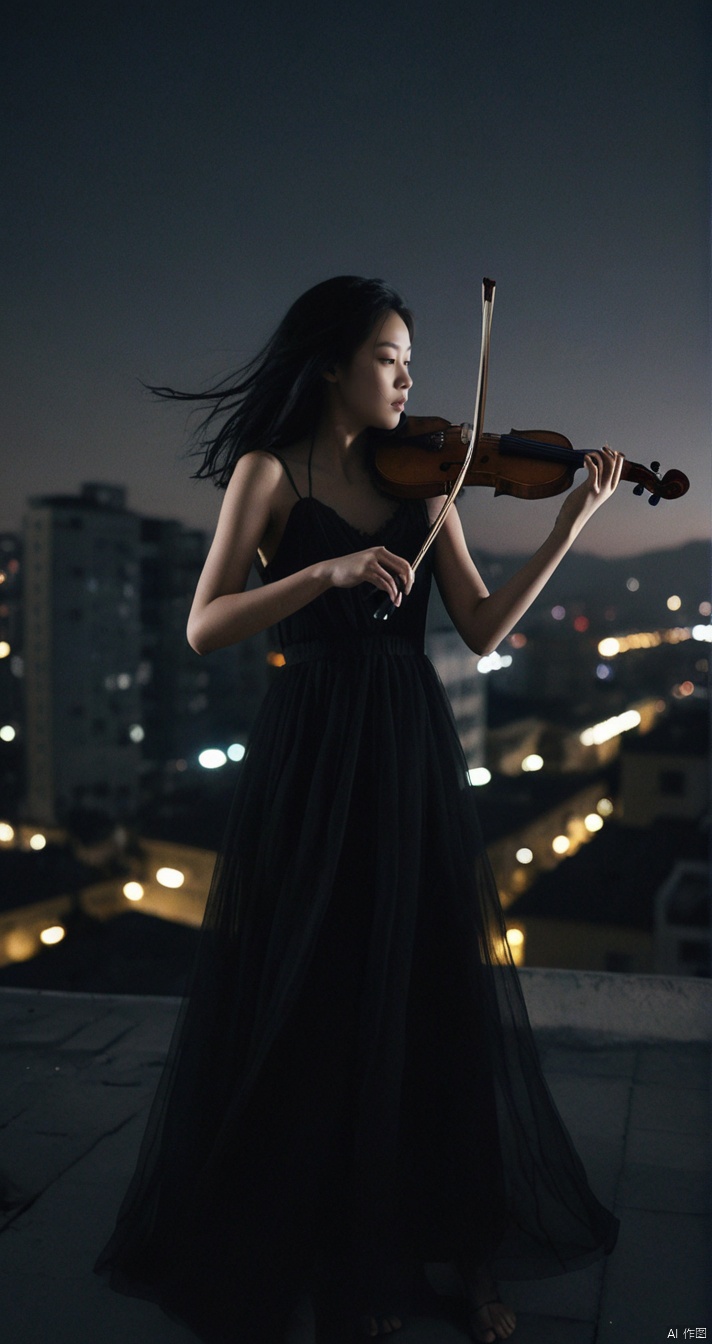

left=97, top=276, right=622, bottom=1344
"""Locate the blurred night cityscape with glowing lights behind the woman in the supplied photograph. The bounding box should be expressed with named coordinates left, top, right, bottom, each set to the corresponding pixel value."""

left=0, top=482, right=712, bottom=993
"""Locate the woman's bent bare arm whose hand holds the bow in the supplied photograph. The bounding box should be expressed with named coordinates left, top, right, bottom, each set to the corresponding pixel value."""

left=188, top=453, right=412, bottom=653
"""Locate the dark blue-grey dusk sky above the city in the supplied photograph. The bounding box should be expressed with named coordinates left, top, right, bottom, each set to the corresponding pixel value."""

left=0, top=0, right=711, bottom=554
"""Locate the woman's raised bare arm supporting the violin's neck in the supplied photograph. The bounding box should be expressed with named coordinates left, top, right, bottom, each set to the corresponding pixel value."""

left=433, top=448, right=623, bottom=655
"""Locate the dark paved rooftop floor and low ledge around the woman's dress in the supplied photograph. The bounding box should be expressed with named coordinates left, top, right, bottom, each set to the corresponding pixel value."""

left=0, top=970, right=712, bottom=1344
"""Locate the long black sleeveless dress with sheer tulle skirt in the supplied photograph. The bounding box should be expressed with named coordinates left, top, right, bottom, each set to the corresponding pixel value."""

left=97, top=481, right=618, bottom=1344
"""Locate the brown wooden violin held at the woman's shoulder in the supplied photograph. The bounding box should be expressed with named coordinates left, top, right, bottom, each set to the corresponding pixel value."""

left=375, top=415, right=689, bottom=504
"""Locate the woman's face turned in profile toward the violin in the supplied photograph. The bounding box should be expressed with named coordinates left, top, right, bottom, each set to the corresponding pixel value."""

left=324, top=312, right=412, bottom=431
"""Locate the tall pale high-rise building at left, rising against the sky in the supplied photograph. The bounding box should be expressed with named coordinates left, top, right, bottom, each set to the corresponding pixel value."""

left=23, top=484, right=144, bottom=824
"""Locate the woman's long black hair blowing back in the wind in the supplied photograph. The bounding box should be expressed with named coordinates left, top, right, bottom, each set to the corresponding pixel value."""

left=150, top=276, right=414, bottom=489
